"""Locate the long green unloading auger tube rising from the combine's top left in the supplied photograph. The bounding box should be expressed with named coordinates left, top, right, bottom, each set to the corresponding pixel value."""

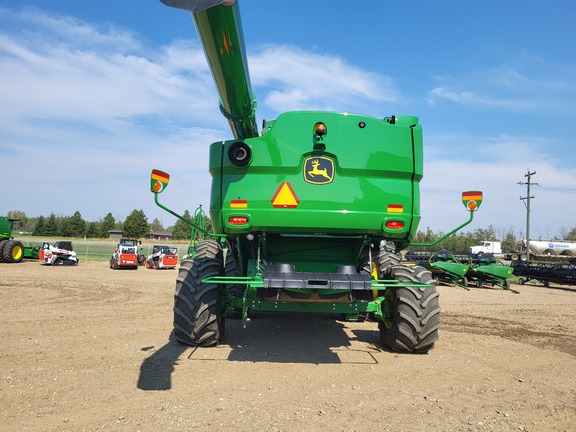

left=160, top=0, right=259, bottom=139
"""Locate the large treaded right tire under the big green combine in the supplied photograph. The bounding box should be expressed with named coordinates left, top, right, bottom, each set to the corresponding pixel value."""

left=378, top=265, right=440, bottom=353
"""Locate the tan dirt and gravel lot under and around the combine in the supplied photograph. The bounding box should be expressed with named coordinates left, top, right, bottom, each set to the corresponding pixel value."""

left=0, top=262, right=576, bottom=431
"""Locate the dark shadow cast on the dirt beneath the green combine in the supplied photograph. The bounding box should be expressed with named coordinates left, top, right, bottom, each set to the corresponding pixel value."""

left=138, top=312, right=382, bottom=390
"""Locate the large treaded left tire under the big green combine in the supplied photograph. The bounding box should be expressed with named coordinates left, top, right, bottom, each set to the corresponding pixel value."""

left=174, top=240, right=224, bottom=346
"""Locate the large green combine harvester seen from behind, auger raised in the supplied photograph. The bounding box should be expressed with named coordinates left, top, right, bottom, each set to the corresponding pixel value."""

left=151, top=0, right=482, bottom=353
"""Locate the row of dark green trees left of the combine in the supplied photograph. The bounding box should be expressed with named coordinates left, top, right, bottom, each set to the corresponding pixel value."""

left=6, top=209, right=211, bottom=240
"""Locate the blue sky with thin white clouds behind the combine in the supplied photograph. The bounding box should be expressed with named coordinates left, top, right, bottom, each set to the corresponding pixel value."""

left=0, top=0, right=576, bottom=239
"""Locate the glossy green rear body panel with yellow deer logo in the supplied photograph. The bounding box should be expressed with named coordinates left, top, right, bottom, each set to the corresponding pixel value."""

left=210, top=112, right=422, bottom=238
